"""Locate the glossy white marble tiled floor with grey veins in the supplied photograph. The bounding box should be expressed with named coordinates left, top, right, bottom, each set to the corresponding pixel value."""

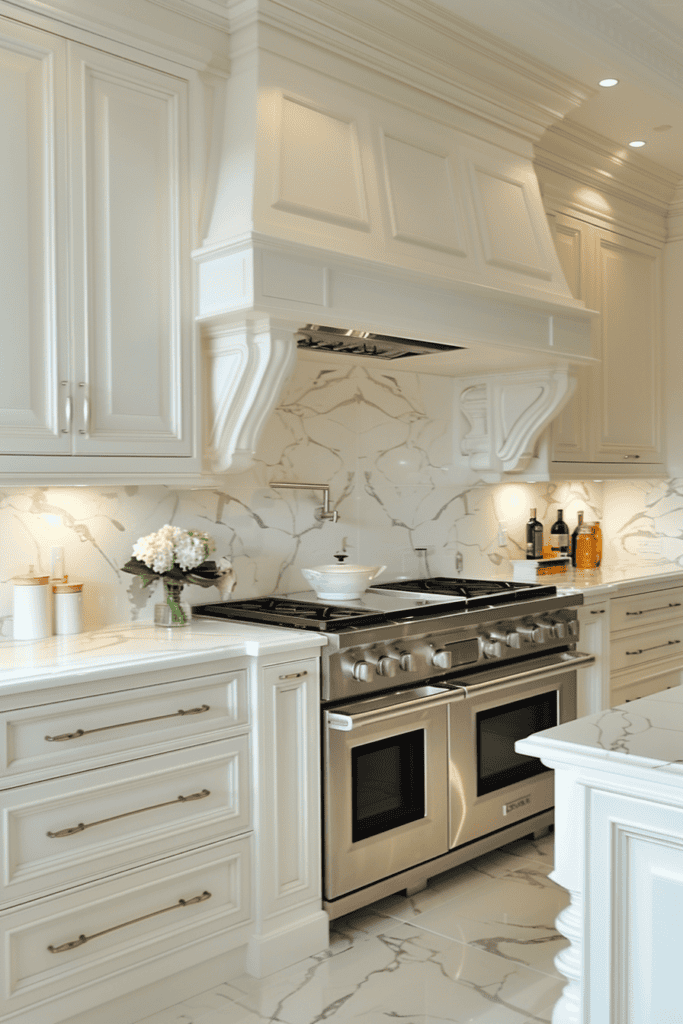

left=132, top=836, right=568, bottom=1024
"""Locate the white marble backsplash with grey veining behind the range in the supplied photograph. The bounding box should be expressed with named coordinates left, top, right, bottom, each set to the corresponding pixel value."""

left=0, top=361, right=683, bottom=636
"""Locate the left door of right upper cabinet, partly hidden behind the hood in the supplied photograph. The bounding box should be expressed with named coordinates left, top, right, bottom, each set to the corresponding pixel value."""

left=550, top=215, right=599, bottom=462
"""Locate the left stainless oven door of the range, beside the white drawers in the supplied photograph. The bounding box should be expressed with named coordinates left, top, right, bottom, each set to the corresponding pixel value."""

left=323, top=686, right=464, bottom=900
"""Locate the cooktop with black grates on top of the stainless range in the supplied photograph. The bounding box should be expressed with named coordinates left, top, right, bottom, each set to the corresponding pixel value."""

left=193, top=577, right=557, bottom=633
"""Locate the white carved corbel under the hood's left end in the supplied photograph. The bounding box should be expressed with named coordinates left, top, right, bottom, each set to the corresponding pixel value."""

left=202, top=317, right=297, bottom=473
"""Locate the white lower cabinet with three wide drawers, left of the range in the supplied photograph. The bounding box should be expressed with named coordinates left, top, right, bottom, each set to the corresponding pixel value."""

left=0, top=648, right=328, bottom=1024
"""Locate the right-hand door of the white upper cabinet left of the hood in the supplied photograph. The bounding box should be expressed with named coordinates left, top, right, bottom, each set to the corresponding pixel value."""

left=69, top=43, right=194, bottom=456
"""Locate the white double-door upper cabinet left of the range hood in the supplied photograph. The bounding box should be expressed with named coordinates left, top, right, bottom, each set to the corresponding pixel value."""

left=0, top=18, right=199, bottom=480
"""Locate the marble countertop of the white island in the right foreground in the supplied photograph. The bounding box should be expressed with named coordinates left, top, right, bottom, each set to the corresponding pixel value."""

left=515, top=686, right=683, bottom=785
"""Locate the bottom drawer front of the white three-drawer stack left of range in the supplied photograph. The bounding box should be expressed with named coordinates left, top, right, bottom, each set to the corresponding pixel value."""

left=0, top=838, right=252, bottom=1019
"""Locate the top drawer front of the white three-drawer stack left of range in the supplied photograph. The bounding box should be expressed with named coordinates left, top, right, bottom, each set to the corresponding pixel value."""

left=0, top=669, right=249, bottom=787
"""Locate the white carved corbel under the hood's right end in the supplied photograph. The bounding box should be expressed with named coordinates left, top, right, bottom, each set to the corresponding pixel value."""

left=460, top=367, right=575, bottom=478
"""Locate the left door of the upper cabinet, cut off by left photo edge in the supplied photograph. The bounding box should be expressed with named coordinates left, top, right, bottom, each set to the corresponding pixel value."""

left=0, top=18, right=70, bottom=455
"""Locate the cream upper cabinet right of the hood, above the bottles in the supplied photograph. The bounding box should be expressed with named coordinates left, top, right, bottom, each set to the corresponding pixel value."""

left=551, top=214, right=664, bottom=476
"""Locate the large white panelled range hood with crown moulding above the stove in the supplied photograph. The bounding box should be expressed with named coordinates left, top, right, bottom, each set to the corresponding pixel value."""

left=189, top=0, right=592, bottom=469
